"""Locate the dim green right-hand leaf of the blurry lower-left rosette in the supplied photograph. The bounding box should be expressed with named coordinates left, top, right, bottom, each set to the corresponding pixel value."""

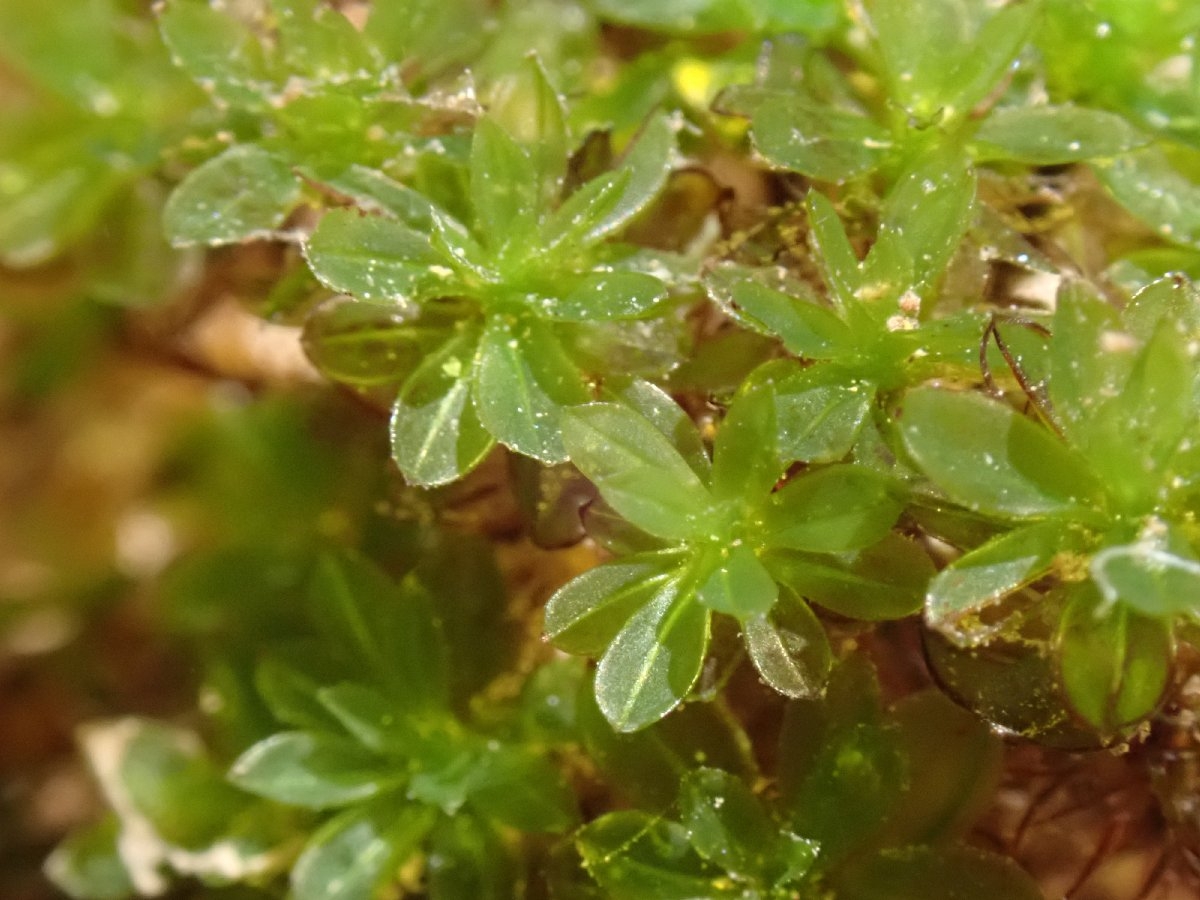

left=469, top=748, right=580, bottom=834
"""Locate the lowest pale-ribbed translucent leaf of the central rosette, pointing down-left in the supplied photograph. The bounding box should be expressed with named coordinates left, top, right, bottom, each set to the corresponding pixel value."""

left=595, top=578, right=709, bottom=731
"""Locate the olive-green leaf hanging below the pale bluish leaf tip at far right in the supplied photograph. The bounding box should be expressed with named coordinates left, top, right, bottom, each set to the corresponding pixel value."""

left=1057, top=583, right=1175, bottom=736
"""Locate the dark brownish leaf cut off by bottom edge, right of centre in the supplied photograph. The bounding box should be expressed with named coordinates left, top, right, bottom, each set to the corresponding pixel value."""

left=836, top=846, right=1044, bottom=900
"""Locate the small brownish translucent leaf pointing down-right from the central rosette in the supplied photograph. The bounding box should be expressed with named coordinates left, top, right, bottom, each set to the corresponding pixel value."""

left=742, top=590, right=833, bottom=700
